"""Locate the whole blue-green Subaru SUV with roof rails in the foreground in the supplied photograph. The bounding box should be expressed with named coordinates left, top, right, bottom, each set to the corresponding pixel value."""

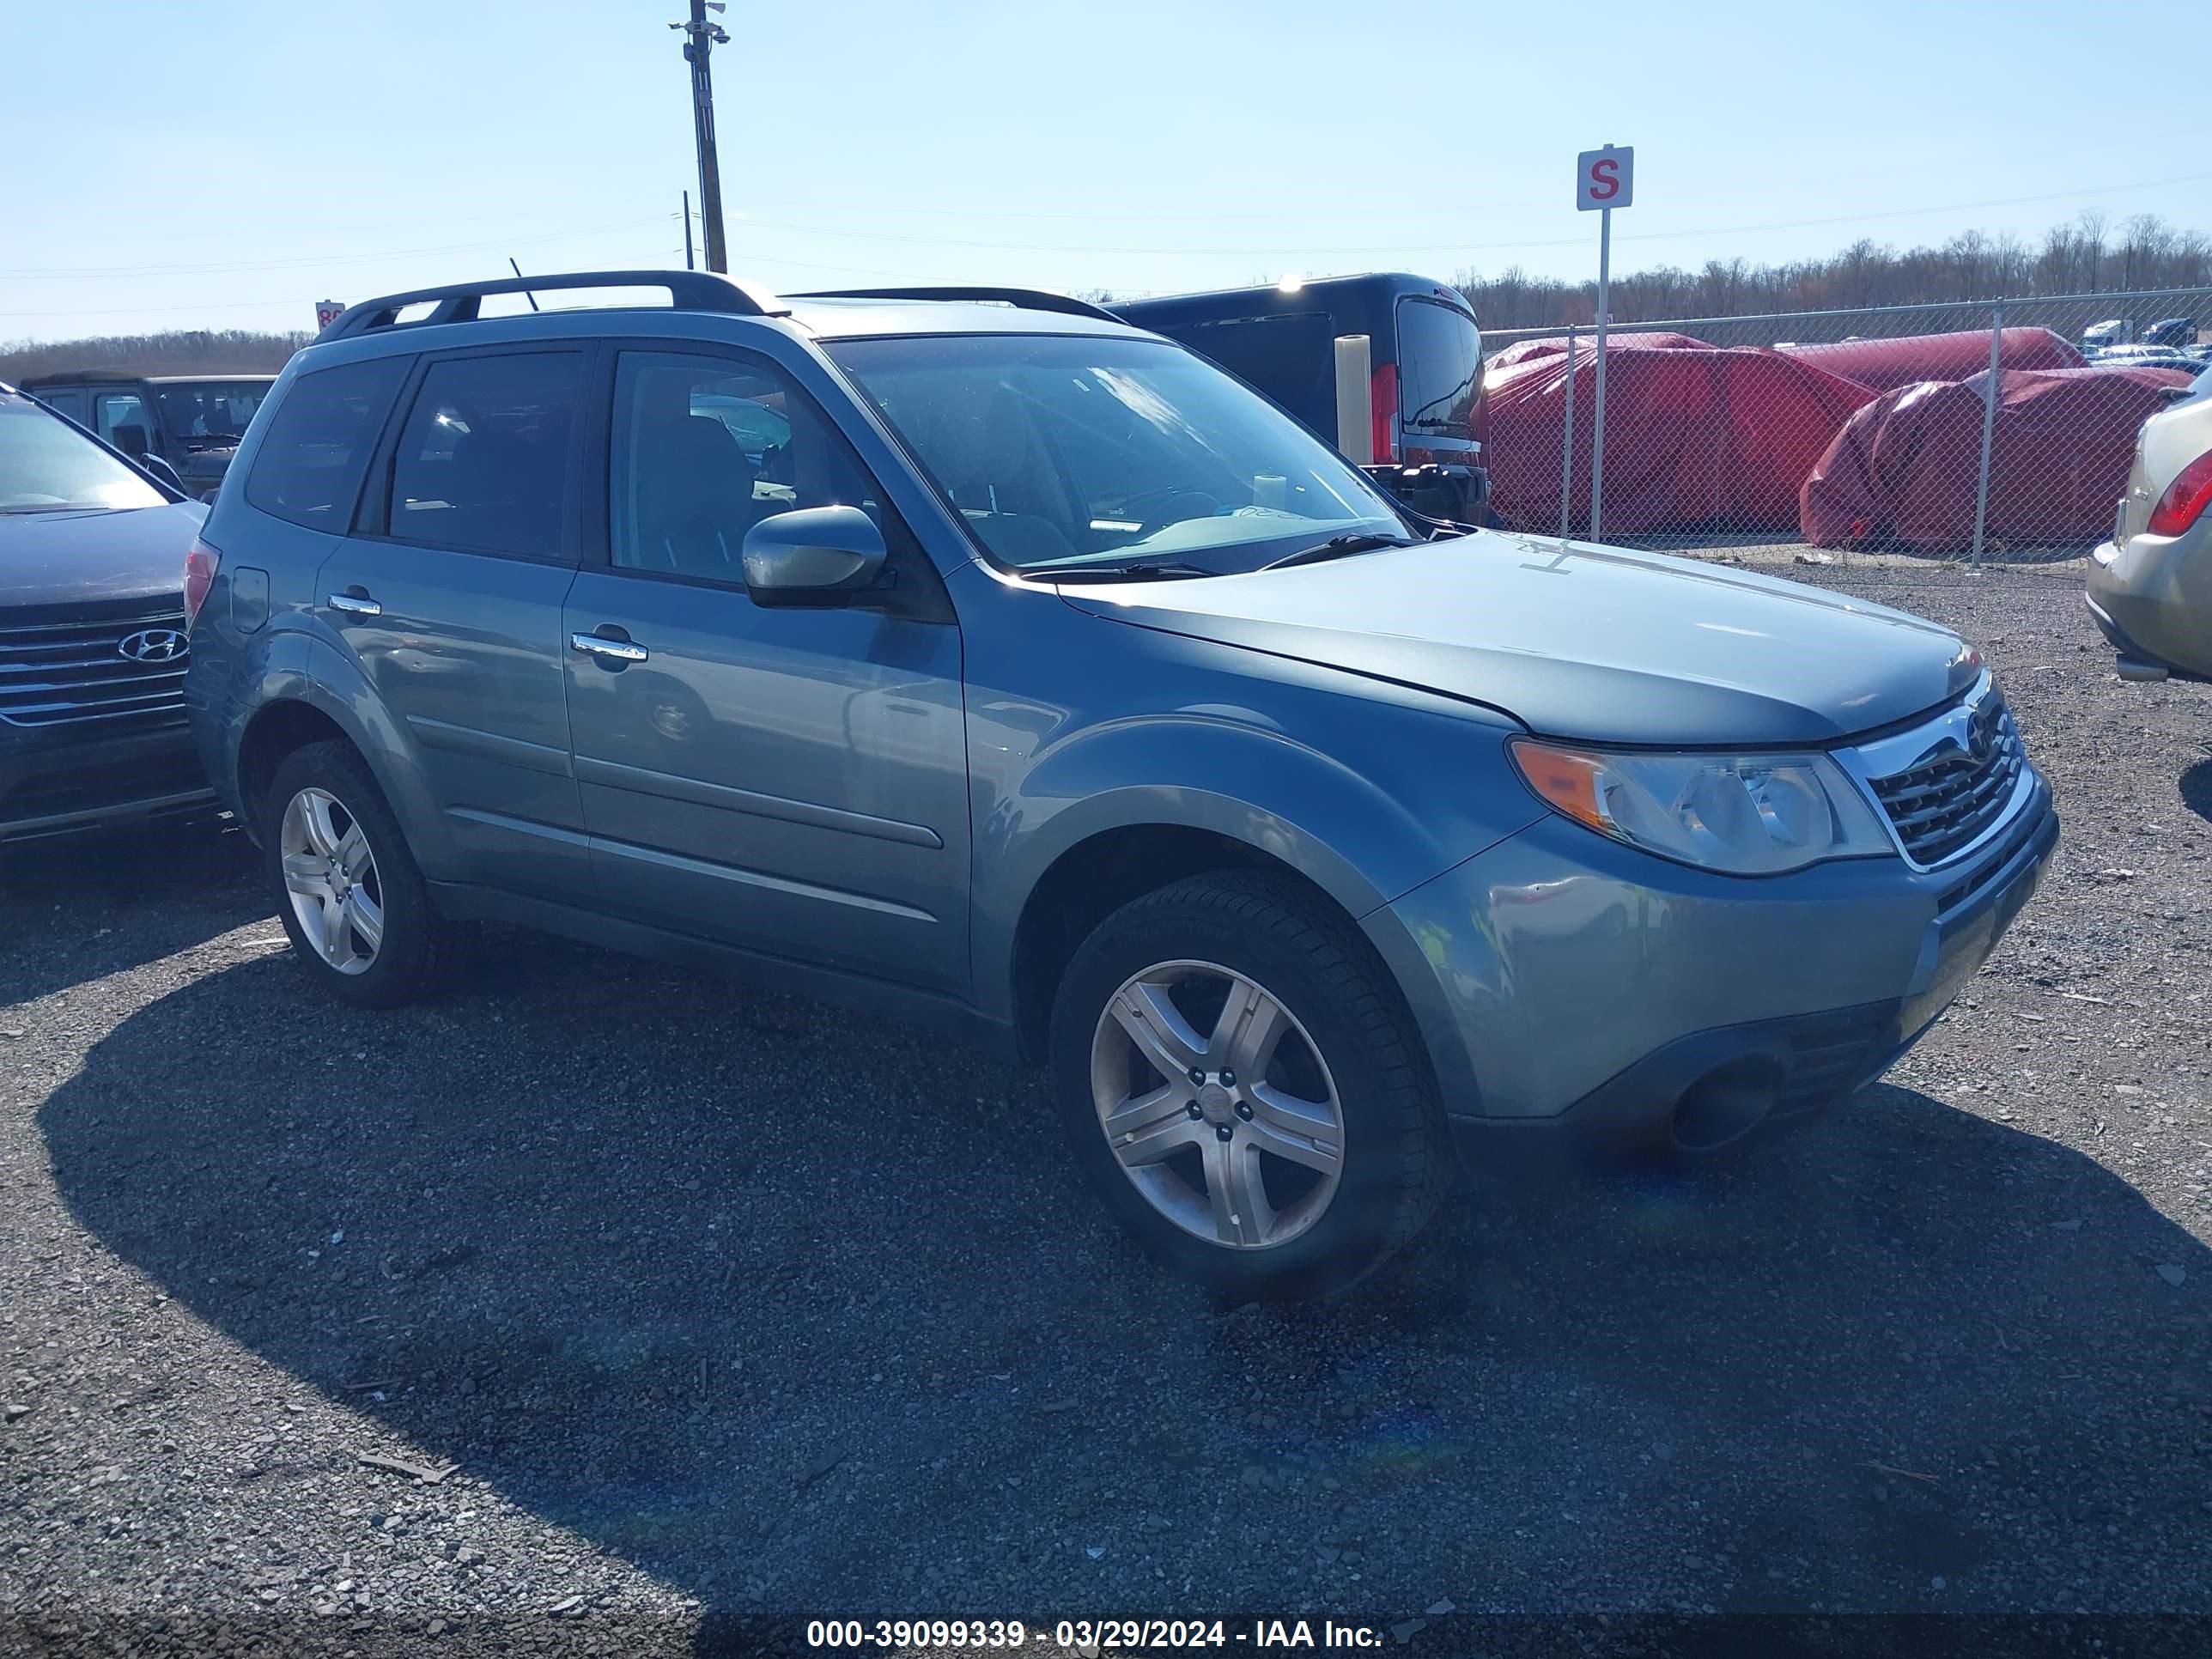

left=185, top=272, right=2057, bottom=1297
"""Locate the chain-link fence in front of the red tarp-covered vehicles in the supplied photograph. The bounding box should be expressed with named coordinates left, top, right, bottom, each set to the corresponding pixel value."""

left=1484, top=288, right=2212, bottom=560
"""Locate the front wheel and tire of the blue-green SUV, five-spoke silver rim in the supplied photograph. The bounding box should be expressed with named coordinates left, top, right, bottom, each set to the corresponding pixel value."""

left=1051, top=872, right=1451, bottom=1298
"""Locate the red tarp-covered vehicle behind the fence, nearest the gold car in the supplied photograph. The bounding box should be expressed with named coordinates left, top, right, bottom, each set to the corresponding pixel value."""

left=1796, top=367, right=2190, bottom=553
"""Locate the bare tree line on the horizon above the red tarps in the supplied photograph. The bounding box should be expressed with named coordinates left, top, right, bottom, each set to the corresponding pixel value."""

left=1458, top=212, right=2212, bottom=330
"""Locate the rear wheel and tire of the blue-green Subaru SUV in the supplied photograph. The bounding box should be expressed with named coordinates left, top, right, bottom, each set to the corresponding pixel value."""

left=261, top=738, right=462, bottom=1009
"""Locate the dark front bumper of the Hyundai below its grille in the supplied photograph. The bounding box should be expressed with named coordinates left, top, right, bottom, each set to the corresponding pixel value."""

left=0, top=723, right=215, bottom=841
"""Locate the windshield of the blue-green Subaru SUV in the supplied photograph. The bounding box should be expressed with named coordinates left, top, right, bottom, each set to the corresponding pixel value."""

left=827, top=334, right=1407, bottom=575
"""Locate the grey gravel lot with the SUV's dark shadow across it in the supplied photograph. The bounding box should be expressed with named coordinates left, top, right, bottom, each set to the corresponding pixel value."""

left=0, top=562, right=2212, bottom=1655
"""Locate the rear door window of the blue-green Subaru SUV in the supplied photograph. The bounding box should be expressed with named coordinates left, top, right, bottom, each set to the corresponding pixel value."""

left=387, top=352, right=584, bottom=560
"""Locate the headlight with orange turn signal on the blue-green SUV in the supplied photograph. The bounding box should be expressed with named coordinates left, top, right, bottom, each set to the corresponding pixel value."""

left=1509, top=737, right=1896, bottom=876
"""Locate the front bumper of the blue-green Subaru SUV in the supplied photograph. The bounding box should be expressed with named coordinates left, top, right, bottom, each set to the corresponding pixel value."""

left=1370, top=779, right=2059, bottom=1151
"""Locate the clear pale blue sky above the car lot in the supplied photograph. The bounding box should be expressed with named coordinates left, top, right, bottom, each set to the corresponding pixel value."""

left=0, top=0, right=2212, bottom=341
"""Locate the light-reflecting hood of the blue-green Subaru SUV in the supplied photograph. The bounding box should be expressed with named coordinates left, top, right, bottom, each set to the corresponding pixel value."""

left=1061, top=531, right=1980, bottom=748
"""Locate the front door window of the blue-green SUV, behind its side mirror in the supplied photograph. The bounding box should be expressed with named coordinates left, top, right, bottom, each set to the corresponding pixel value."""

left=608, top=352, right=902, bottom=586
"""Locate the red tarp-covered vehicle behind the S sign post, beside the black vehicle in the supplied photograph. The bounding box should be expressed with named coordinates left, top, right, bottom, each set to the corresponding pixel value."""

left=1484, top=338, right=1875, bottom=538
